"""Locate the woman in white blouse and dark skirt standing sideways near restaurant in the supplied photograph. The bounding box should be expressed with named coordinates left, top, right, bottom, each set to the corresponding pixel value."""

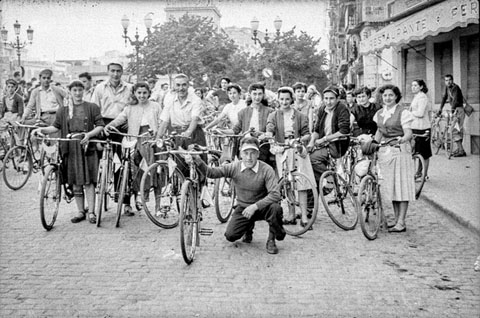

left=410, top=79, right=432, bottom=177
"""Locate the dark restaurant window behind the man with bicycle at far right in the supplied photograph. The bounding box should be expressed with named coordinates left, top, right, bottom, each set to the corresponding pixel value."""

left=434, top=41, right=455, bottom=104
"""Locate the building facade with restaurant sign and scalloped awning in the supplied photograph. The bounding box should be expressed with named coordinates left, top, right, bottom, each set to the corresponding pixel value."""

left=331, top=0, right=480, bottom=154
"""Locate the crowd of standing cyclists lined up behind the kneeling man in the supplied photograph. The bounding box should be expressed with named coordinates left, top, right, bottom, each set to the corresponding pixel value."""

left=0, top=62, right=464, bottom=256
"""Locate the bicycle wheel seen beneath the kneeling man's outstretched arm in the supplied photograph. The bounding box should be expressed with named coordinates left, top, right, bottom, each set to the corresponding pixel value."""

left=214, top=178, right=236, bottom=223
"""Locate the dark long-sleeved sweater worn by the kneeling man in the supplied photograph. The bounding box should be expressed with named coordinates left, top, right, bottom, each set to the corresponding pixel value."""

left=197, top=160, right=281, bottom=210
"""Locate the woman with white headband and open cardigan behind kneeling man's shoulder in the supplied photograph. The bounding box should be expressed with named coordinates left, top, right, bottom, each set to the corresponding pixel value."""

left=266, top=87, right=316, bottom=226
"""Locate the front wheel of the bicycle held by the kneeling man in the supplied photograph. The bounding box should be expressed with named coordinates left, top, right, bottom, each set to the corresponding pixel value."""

left=179, top=180, right=200, bottom=264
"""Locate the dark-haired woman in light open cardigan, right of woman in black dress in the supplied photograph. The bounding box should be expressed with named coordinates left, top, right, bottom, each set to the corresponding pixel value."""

left=105, top=82, right=161, bottom=213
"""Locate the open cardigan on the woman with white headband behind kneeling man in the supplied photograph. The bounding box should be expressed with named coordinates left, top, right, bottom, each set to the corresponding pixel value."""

left=267, top=109, right=310, bottom=143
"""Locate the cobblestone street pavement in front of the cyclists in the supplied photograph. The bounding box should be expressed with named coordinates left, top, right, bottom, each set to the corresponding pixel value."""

left=0, top=176, right=480, bottom=317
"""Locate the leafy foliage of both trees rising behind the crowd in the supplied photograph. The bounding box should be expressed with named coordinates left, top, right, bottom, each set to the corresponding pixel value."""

left=134, top=15, right=327, bottom=89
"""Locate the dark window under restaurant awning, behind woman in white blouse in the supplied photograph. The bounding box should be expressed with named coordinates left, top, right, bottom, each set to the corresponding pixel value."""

left=402, top=45, right=428, bottom=103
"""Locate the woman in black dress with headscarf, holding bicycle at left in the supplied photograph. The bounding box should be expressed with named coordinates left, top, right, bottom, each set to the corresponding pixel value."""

left=32, top=80, right=104, bottom=223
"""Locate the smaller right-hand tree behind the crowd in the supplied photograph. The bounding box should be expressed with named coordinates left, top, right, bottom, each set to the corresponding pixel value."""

left=254, top=28, right=328, bottom=87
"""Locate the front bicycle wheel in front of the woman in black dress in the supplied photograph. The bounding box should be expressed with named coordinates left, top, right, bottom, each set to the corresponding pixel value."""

left=40, top=165, right=62, bottom=231
